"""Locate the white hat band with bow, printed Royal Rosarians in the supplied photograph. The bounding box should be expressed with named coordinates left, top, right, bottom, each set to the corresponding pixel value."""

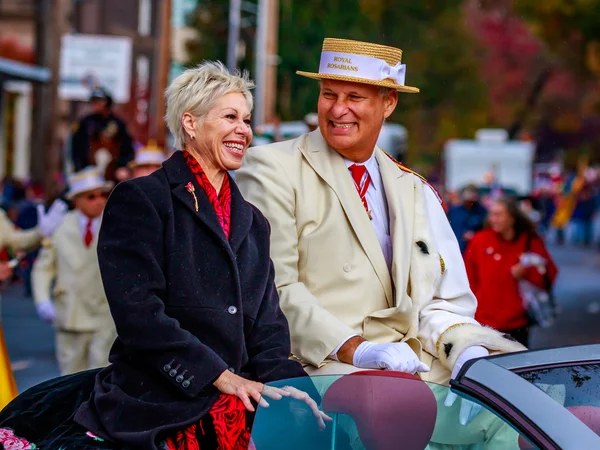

left=319, top=52, right=406, bottom=86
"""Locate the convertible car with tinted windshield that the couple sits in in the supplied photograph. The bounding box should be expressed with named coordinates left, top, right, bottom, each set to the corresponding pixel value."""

left=252, top=345, right=600, bottom=450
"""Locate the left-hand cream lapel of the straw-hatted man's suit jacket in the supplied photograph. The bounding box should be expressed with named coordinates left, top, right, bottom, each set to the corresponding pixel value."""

left=300, top=130, right=393, bottom=307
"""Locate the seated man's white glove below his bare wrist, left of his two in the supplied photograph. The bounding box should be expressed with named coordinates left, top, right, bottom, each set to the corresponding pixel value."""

left=352, top=342, right=431, bottom=374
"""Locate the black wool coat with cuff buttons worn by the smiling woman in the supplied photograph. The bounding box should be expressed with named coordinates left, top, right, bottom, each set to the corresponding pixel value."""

left=75, top=152, right=306, bottom=448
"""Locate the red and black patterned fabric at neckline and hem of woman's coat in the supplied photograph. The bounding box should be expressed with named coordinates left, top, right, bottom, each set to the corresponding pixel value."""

left=159, top=152, right=254, bottom=450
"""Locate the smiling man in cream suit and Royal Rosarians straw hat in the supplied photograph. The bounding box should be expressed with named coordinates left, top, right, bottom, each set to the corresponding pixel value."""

left=236, top=38, right=524, bottom=444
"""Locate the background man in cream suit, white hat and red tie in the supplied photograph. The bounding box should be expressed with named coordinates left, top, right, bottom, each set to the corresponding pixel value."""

left=32, top=167, right=116, bottom=375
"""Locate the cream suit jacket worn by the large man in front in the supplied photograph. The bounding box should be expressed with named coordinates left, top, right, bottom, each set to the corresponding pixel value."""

left=236, top=130, right=524, bottom=370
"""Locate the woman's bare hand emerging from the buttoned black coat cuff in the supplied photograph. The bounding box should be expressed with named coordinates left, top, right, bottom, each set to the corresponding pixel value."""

left=213, top=370, right=290, bottom=412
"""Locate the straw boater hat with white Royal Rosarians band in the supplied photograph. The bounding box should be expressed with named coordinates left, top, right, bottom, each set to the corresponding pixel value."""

left=296, top=38, right=419, bottom=93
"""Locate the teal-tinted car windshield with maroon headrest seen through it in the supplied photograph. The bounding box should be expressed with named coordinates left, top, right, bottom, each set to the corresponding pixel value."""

left=252, top=371, right=535, bottom=450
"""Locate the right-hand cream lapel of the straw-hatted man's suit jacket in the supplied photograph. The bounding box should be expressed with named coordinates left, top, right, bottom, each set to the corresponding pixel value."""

left=375, top=148, right=414, bottom=306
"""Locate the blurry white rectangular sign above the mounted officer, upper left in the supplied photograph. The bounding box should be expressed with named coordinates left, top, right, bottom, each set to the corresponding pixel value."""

left=58, top=34, right=132, bottom=103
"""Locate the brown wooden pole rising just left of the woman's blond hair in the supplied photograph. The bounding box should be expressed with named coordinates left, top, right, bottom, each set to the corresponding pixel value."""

left=150, top=0, right=172, bottom=146
